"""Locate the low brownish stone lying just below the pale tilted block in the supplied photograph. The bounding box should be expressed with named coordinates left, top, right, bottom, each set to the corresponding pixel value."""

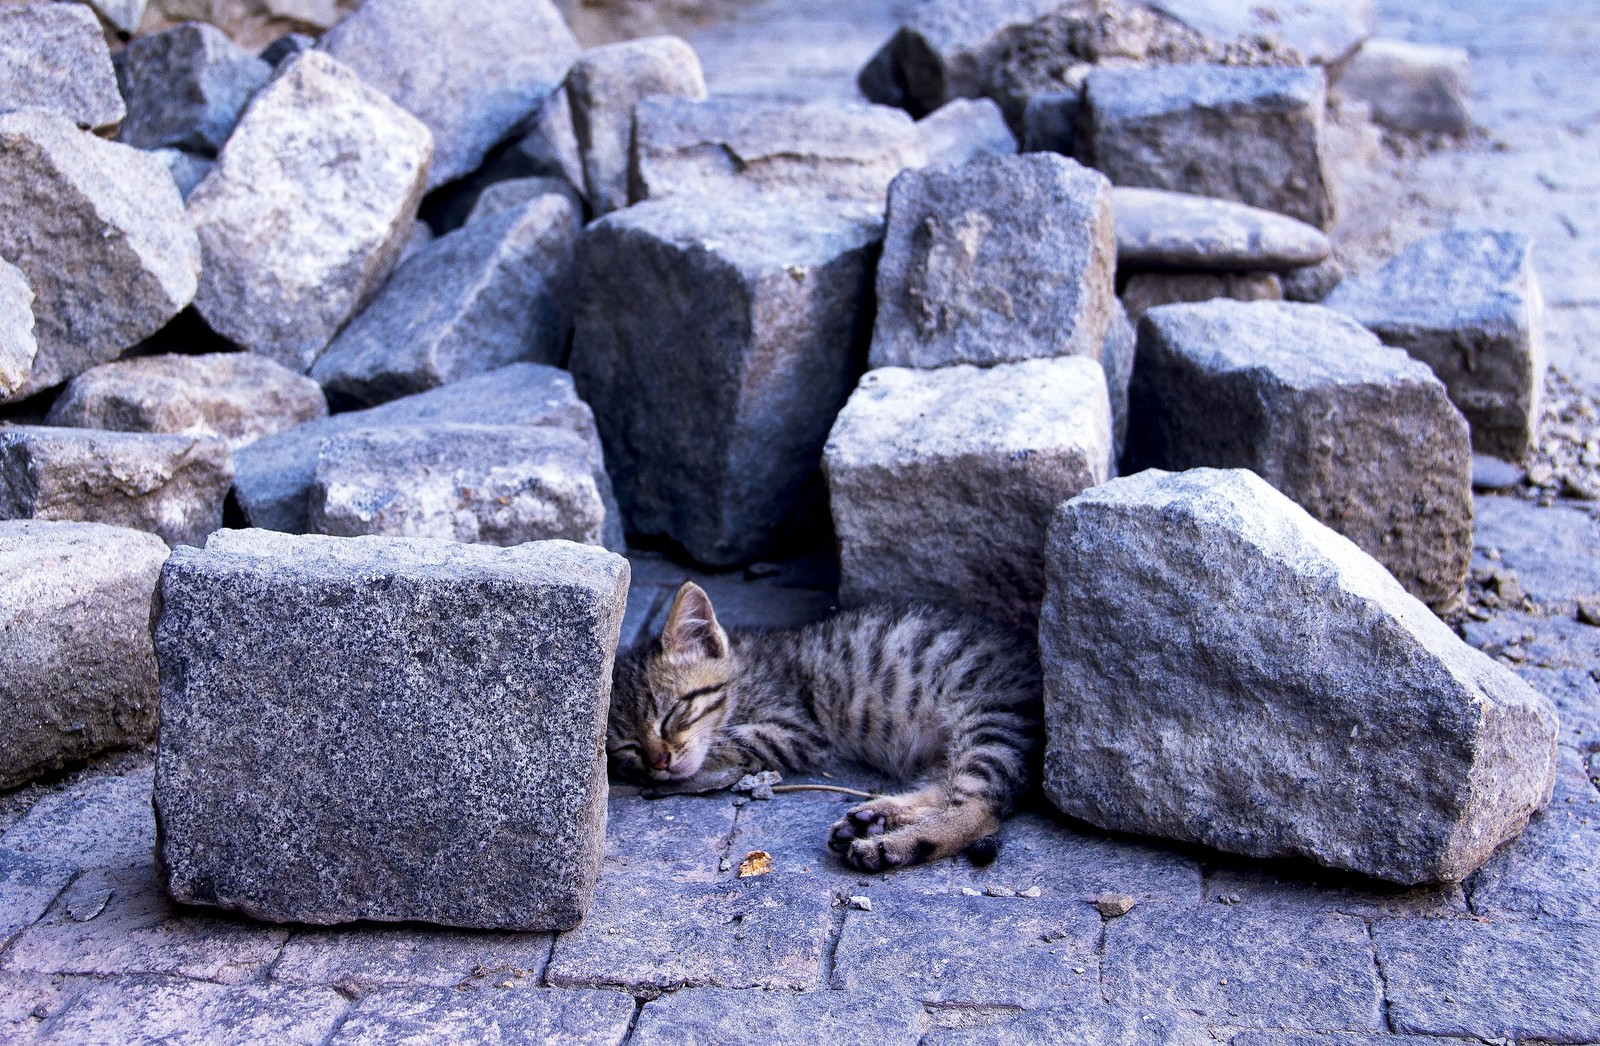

left=46, top=352, right=328, bottom=449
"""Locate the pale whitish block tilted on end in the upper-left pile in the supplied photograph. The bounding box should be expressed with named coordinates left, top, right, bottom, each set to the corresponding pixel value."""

left=189, top=51, right=430, bottom=371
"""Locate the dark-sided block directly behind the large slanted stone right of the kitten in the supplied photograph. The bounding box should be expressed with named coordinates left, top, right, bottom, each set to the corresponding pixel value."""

left=1128, top=301, right=1472, bottom=609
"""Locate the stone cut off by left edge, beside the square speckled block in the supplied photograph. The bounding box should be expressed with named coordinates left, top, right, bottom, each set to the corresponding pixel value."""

left=0, top=520, right=166, bottom=788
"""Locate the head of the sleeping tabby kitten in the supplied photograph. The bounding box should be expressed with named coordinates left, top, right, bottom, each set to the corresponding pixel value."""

left=606, top=582, right=738, bottom=781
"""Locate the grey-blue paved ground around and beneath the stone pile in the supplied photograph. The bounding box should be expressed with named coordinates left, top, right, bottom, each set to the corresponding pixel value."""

left=0, top=0, right=1600, bottom=1046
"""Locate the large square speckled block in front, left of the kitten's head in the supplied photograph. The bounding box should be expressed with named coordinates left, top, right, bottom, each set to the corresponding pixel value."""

left=155, top=531, right=629, bottom=931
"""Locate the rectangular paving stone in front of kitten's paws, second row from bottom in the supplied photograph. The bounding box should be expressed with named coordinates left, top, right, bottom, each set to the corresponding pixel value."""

left=832, top=888, right=1101, bottom=1009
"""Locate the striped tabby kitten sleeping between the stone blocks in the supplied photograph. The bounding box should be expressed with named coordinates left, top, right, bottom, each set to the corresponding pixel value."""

left=606, top=582, right=1042, bottom=872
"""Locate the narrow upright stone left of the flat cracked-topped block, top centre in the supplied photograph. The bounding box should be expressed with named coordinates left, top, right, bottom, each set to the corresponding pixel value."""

left=566, top=37, right=706, bottom=214
